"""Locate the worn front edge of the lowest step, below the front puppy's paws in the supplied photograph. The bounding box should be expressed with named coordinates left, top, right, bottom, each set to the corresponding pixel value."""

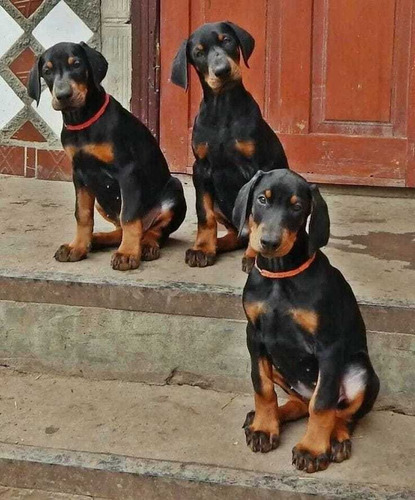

left=0, top=442, right=415, bottom=500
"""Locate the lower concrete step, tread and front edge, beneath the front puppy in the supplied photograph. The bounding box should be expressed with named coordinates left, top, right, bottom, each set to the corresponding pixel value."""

left=0, top=369, right=415, bottom=500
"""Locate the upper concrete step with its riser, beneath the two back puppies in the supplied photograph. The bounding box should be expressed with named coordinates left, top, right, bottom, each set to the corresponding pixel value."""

left=0, top=176, right=415, bottom=413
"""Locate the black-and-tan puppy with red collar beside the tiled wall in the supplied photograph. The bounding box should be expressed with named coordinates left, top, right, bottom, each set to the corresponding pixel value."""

left=28, top=42, right=186, bottom=271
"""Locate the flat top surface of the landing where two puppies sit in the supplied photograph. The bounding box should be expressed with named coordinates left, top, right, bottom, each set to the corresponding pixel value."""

left=0, top=176, right=415, bottom=307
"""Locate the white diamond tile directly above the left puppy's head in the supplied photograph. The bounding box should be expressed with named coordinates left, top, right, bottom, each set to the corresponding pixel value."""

left=33, top=0, right=93, bottom=48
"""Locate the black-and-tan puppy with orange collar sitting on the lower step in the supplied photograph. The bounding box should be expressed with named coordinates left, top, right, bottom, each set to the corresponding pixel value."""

left=234, top=170, right=379, bottom=472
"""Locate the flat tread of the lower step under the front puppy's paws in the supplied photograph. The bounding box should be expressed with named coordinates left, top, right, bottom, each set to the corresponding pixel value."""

left=0, top=369, right=415, bottom=498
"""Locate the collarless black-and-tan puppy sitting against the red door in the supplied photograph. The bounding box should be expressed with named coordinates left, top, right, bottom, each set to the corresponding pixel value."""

left=171, top=22, right=288, bottom=272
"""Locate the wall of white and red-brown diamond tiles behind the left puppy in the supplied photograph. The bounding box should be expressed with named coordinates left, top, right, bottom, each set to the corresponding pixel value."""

left=0, top=0, right=101, bottom=180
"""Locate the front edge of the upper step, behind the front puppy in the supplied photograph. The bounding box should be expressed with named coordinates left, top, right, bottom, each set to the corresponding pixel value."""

left=0, top=269, right=415, bottom=334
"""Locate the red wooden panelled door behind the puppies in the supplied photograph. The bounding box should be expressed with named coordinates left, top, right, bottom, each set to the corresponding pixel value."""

left=160, top=0, right=415, bottom=186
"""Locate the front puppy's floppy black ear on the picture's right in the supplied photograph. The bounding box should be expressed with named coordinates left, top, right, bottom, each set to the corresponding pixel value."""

left=308, top=184, right=330, bottom=256
